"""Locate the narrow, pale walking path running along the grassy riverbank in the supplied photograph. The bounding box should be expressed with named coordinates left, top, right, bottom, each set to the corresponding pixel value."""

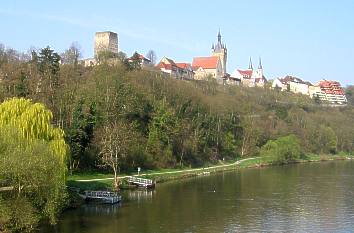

left=75, top=157, right=259, bottom=182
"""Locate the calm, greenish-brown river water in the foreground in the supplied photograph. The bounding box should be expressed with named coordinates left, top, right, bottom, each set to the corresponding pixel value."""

left=41, top=161, right=354, bottom=233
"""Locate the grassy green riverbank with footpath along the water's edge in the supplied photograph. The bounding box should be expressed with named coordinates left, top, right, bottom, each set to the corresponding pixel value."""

left=68, top=154, right=354, bottom=190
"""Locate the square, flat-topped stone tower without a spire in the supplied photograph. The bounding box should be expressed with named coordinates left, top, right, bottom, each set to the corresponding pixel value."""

left=94, top=31, right=118, bottom=57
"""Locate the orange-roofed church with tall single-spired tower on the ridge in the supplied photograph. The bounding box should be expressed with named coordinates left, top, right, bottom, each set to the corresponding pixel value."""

left=192, top=30, right=227, bottom=80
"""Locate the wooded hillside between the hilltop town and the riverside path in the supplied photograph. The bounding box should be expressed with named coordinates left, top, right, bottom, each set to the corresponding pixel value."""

left=0, top=48, right=354, bottom=173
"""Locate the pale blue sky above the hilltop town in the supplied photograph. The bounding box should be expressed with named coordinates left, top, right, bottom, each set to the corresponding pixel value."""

left=0, top=0, right=354, bottom=86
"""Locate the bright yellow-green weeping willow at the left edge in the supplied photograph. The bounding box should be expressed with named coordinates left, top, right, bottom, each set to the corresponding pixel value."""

left=0, top=98, right=67, bottom=231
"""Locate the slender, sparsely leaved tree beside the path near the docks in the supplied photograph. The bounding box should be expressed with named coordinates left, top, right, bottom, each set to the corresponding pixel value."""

left=99, top=121, right=135, bottom=189
